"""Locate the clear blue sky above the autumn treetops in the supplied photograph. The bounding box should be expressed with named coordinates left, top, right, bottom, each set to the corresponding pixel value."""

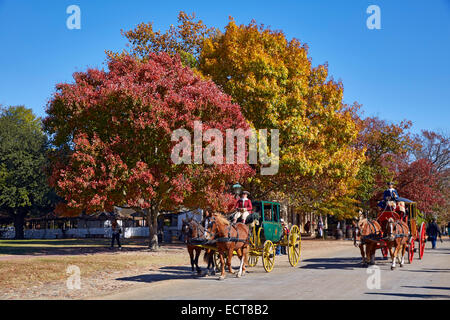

left=0, top=0, right=450, bottom=132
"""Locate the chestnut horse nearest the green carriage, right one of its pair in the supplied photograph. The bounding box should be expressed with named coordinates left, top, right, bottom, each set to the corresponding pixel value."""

left=209, top=213, right=249, bottom=280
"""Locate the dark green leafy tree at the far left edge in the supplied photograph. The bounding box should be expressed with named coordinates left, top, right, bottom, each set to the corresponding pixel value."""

left=0, top=106, right=57, bottom=239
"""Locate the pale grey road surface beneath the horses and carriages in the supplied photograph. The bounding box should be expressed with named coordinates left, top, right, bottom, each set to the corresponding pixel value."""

left=91, top=238, right=450, bottom=300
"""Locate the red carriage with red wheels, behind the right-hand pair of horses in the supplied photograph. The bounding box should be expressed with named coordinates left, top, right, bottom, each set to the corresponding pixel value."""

left=377, top=198, right=426, bottom=263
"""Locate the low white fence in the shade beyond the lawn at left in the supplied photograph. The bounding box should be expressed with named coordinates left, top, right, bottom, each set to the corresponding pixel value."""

left=0, top=227, right=149, bottom=239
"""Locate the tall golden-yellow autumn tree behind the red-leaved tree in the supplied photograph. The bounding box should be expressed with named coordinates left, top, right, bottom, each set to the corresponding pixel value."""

left=114, top=13, right=363, bottom=218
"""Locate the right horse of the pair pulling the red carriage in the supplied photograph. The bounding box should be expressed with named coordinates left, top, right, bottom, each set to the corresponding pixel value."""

left=385, top=218, right=409, bottom=270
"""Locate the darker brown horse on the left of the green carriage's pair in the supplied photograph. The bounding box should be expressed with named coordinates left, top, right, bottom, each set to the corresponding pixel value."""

left=181, top=218, right=215, bottom=274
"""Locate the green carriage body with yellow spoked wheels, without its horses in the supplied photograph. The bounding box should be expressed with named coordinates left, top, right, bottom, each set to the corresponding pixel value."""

left=248, top=201, right=301, bottom=272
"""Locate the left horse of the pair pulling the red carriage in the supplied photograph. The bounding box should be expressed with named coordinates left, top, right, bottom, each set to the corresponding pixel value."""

left=353, top=218, right=382, bottom=266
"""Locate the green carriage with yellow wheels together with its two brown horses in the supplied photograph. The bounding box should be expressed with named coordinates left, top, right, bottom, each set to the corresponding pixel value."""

left=181, top=201, right=301, bottom=277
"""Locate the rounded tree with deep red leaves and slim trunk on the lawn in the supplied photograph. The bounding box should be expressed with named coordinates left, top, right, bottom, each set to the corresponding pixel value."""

left=44, top=53, right=252, bottom=249
